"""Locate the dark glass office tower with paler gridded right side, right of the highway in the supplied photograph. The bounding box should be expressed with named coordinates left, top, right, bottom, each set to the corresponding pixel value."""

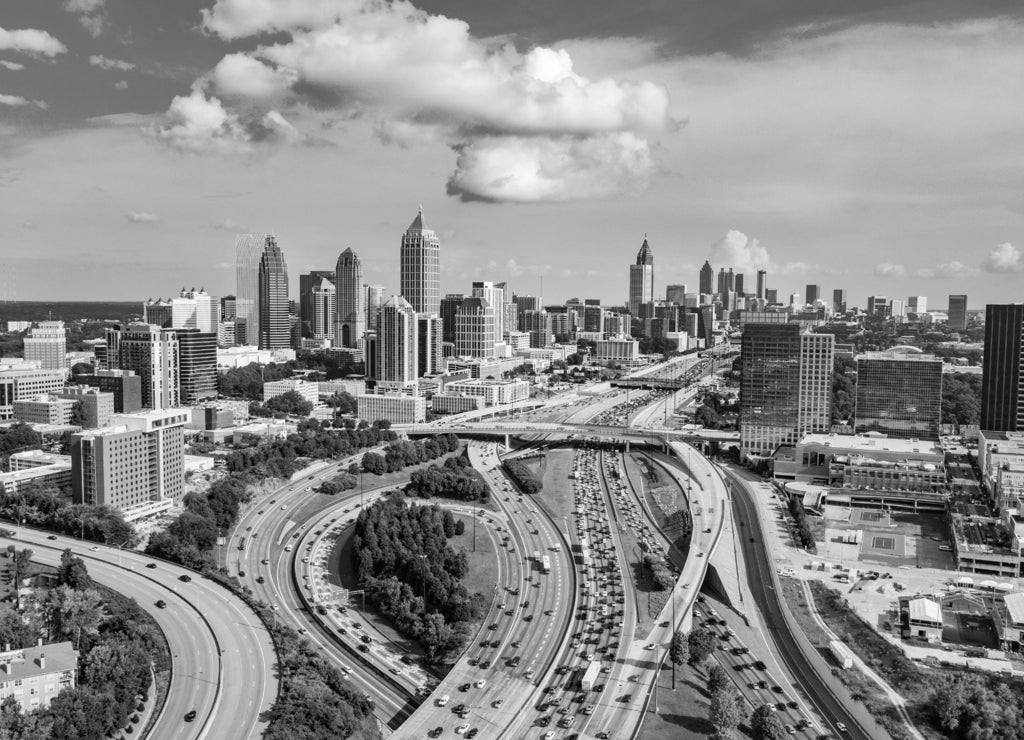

left=739, top=322, right=835, bottom=459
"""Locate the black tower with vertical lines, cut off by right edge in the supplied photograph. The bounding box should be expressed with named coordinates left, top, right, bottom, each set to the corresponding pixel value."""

left=974, top=305, right=1024, bottom=432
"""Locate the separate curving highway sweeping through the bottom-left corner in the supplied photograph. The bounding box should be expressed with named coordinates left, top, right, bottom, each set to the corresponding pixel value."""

left=2, top=528, right=278, bottom=740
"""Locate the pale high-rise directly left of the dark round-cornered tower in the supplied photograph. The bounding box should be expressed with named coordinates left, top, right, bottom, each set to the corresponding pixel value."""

left=114, top=323, right=180, bottom=409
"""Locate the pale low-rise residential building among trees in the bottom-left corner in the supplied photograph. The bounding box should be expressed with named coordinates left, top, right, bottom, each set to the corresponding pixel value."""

left=0, top=640, right=79, bottom=713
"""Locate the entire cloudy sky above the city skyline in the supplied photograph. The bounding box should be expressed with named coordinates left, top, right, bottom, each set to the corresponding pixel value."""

left=0, top=0, right=1024, bottom=313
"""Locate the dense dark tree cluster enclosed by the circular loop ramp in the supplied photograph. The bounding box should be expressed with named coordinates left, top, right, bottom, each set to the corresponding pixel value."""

left=352, top=495, right=482, bottom=660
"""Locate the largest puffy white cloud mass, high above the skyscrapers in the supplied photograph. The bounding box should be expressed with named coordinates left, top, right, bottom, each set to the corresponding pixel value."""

left=153, top=0, right=674, bottom=203
